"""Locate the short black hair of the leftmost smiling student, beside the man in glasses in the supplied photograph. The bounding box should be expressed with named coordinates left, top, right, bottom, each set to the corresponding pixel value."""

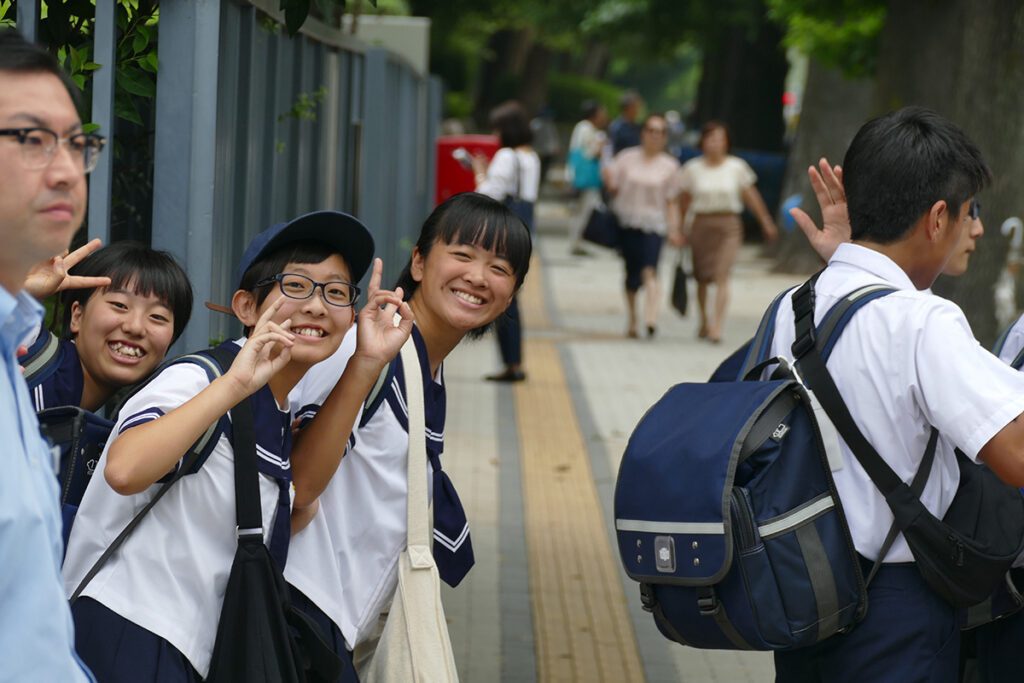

left=61, top=241, right=193, bottom=343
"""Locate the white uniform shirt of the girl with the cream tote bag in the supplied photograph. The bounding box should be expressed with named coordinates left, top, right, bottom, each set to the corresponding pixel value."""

left=285, top=327, right=441, bottom=650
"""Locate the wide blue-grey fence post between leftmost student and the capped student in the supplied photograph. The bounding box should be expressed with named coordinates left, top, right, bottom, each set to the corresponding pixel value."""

left=153, top=0, right=220, bottom=350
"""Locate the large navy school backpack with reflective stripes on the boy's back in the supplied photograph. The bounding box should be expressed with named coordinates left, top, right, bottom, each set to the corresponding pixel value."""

left=614, top=287, right=901, bottom=650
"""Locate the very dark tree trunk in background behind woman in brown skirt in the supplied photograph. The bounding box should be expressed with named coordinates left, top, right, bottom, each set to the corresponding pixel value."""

left=693, top=3, right=788, bottom=152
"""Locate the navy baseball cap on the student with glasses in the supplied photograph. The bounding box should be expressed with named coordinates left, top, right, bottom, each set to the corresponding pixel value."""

left=234, top=211, right=374, bottom=285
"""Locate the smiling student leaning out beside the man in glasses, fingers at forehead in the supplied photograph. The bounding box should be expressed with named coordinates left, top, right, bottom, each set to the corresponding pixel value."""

left=19, top=240, right=193, bottom=412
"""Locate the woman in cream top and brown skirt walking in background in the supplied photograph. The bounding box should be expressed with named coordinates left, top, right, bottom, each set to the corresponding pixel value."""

left=669, top=121, right=778, bottom=343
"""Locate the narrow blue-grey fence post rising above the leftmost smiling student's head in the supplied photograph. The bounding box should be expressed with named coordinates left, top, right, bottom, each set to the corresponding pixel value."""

left=87, top=0, right=118, bottom=244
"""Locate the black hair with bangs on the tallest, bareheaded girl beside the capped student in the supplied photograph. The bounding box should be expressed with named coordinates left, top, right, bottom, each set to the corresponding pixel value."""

left=395, top=193, right=534, bottom=338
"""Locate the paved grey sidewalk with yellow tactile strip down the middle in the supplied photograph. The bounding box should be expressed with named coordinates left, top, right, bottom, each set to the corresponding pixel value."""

left=443, top=203, right=799, bottom=683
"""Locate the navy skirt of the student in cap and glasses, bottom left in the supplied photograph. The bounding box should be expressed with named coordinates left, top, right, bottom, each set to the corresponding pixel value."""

left=71, top=598, right=203, bottom=683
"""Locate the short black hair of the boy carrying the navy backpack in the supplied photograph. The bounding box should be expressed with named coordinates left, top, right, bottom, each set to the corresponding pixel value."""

left=843, top=106, right=992, bottom=244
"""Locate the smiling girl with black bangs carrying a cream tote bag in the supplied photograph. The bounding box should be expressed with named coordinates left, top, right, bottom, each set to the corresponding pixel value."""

left=285, top=193, right=531, bottom=679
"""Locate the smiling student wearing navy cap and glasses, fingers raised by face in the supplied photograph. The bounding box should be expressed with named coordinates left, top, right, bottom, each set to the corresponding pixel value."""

left=63, top=211, right=412, bottom=683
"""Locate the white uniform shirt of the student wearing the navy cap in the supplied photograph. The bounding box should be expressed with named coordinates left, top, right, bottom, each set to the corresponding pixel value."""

left=63, top=340, right=299, bottom=678
